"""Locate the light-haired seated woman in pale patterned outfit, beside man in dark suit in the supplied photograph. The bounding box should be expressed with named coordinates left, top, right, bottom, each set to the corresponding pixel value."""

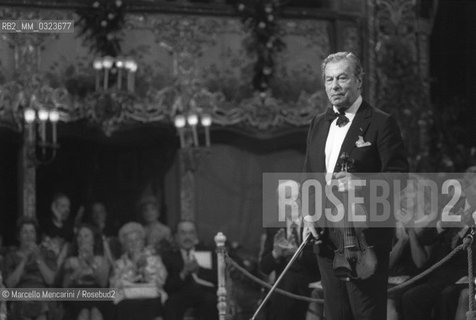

left=111, top=222, right=167, bottom=320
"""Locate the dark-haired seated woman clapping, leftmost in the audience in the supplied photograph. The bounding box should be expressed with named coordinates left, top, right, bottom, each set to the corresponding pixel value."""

left=4, top=217, right=56, bottom=320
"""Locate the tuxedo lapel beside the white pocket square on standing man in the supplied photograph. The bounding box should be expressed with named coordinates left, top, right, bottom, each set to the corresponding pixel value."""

left=334, top=101, right=372, bottom=171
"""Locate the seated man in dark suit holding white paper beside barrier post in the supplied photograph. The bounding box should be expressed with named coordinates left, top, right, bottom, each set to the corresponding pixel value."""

left=162, top=220, right=218, bottom=320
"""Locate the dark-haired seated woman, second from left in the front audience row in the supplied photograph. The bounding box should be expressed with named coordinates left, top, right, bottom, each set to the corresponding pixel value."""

left=63, top=225, right=110, bottom=320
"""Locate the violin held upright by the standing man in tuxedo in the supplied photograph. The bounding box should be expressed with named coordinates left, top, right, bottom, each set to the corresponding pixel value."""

left=329, top=153, right=377, bottom=281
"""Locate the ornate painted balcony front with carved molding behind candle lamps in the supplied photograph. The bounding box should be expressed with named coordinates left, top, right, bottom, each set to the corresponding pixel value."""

left=0, top=1, right=364, bottom=135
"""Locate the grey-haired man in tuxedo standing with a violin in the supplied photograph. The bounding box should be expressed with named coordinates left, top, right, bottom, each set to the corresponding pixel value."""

left=303, top=52, right=408, bottom=320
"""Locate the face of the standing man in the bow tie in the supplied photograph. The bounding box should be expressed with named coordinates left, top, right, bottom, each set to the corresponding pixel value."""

left=324, top=60, right=362, bottom=109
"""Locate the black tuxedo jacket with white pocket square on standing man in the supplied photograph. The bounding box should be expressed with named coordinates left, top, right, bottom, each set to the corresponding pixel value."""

left=304, top=101, right=408, bottom=250
